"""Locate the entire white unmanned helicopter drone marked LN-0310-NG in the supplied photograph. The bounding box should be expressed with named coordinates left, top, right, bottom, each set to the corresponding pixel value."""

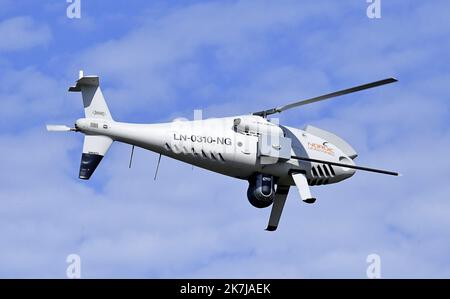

left=47, top=71, right=399, bottom=231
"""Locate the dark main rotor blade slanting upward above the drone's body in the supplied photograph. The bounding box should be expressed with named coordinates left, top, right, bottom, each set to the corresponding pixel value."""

left=253, top=77, right=398, bottom=116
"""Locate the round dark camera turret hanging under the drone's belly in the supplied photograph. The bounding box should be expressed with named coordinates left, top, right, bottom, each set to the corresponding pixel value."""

left=247, top=173, right=275, bottom=208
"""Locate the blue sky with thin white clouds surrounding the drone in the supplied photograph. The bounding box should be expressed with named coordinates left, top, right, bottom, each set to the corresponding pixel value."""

left=0, top=0, right=450, bottom=278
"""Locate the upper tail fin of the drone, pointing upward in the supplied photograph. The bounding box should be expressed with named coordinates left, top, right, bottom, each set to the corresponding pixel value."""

left=69, top=71, right=112, bottom=119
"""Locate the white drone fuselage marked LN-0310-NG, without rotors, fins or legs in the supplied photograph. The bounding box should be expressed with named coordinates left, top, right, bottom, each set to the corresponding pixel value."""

left=76, top=115, right=355, bottom=185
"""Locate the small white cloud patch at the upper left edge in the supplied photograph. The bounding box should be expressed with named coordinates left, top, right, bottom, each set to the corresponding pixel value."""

left=0, top=17, right=52, bottom=52
